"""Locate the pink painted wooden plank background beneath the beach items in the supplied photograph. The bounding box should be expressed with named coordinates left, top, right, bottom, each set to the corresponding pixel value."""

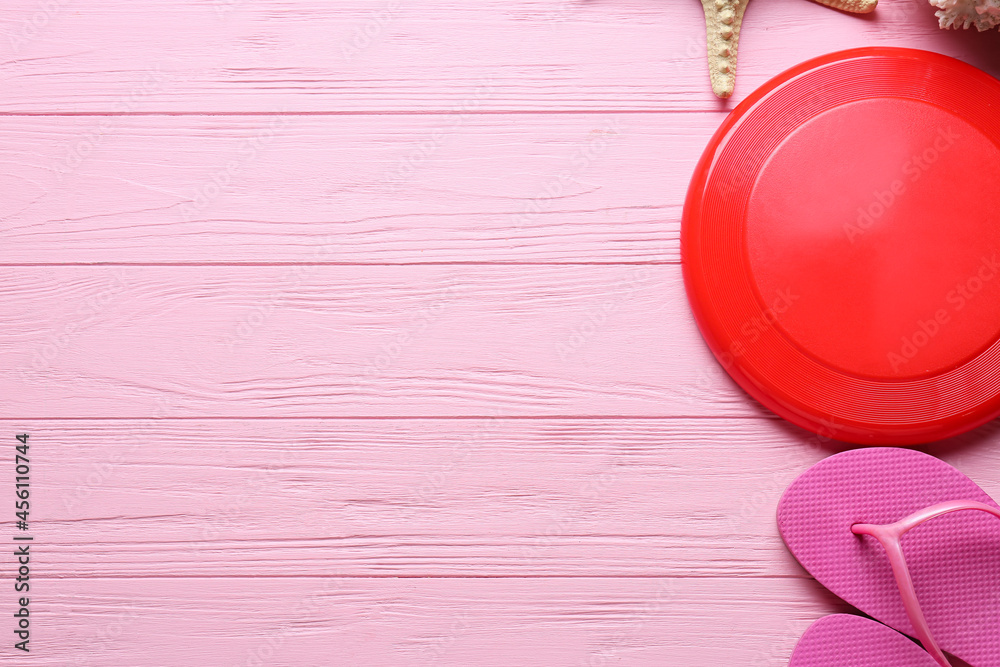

left=0, top=0, right=1000, bottom=667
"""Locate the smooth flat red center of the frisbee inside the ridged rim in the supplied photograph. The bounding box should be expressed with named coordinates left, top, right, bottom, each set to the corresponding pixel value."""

left=746, top=97, right=1000, bottom=381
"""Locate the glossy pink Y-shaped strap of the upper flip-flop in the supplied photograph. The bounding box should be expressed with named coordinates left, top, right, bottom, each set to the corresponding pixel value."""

left=851, top=500, right=1000, bottom=667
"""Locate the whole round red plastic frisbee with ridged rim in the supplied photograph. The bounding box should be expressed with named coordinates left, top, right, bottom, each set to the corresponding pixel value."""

left=681, top=48, right=1000, bottom=445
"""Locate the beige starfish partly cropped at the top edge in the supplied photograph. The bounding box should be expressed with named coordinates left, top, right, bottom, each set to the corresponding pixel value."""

left=701, top=0, right=878, bottom=97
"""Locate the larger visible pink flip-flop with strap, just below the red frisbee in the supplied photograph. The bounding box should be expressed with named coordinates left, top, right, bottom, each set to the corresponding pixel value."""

left=778, top=447, right=1000, bottom=667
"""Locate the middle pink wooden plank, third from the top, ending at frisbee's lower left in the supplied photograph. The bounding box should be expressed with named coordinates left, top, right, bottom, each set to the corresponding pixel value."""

left=0, top=265, right=764, bottom=418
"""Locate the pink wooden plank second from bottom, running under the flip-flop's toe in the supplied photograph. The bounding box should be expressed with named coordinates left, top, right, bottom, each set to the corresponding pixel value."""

left=9, top=418, right=1000, bottom=579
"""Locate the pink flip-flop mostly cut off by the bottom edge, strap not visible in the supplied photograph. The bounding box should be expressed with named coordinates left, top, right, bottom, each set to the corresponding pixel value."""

left=788, top=614, right=937, bottom=667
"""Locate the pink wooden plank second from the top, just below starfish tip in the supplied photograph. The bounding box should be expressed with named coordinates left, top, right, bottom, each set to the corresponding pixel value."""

left=0, top=112, right=704, bottom=264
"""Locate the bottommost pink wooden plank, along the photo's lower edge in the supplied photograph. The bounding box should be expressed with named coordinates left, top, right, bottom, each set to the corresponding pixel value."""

left=30, top=577, right=846, bottom=667
